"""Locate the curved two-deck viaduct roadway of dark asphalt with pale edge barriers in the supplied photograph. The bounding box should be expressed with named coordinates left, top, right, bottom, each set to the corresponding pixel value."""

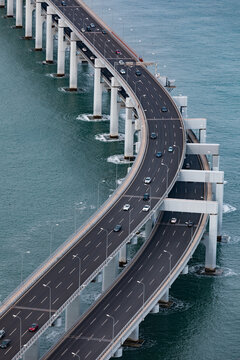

left=0, top=0, right=222, bottom=360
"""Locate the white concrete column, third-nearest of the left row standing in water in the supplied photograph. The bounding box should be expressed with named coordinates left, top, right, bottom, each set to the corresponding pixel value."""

left=93, top=59, right=103, bottom=119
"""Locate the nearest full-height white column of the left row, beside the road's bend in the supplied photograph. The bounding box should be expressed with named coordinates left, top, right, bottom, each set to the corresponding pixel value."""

left=124, top=97, right=134, bottom=160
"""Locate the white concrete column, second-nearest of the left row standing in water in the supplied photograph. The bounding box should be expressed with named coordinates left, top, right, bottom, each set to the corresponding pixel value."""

left=110, top=77, right=119, bottom=139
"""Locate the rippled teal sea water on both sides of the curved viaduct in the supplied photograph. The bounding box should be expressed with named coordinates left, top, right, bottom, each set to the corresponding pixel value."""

left=0, top=0, right=240, bottom=360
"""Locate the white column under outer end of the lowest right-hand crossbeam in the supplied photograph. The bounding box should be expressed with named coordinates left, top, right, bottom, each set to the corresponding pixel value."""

left=205, top=214, right=218, bottom=272
